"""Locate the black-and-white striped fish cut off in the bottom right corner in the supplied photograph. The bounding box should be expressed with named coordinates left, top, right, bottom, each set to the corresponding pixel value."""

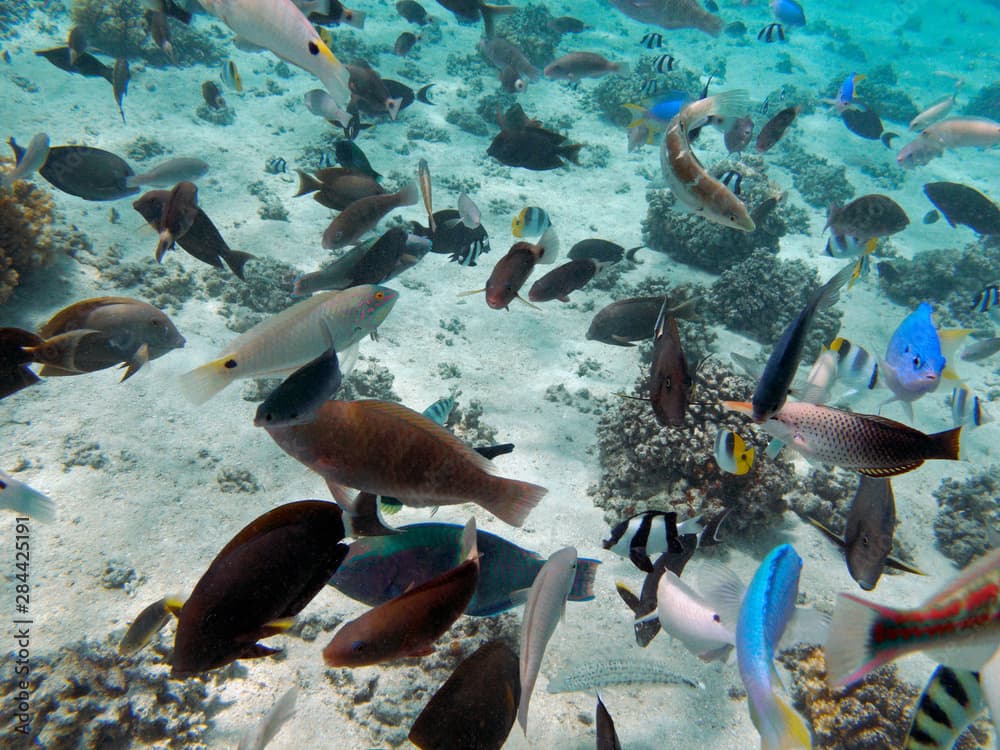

left=903, top=666, right=986, bottom=750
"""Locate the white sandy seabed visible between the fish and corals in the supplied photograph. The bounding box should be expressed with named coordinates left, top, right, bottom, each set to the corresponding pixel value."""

left=0, top=3, right=997, bottom=750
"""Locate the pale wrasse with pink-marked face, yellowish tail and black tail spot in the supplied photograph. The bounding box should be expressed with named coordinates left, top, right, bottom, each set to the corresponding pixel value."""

left=180, top=284, right=399, bottom=404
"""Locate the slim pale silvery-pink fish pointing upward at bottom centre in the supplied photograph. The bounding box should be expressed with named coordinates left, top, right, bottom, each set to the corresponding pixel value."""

left=517, top=547, right=578, bottom=735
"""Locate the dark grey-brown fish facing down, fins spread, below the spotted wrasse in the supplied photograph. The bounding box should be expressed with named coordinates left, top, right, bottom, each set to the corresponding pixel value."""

left=806, top=475, right=924, bottom=591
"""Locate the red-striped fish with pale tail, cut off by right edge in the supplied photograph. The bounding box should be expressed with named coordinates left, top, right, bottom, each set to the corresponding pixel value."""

left=824, top=549, right=1000, bottom=687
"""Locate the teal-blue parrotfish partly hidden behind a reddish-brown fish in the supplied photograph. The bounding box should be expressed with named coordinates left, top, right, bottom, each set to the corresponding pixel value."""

left=330, top=523, right=600, bottom=617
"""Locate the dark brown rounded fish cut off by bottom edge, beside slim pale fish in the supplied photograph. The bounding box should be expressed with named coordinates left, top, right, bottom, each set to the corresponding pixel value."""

left=410, top=641, right=521, bottom=750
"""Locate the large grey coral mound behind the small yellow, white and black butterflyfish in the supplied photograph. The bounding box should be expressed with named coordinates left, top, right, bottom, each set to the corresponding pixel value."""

left=588, top=360, right=795, bottom=533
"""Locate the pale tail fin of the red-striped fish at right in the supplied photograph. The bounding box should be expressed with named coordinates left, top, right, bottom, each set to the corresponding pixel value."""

left=823, top=594, right=904, bottom=687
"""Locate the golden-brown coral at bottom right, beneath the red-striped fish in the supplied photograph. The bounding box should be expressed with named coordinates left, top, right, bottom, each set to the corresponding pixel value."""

left=779, top=645, right=919, bottom=750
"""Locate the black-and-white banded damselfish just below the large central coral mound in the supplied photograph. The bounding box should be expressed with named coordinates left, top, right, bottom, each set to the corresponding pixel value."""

left=602, top=510, right=726, bottom=573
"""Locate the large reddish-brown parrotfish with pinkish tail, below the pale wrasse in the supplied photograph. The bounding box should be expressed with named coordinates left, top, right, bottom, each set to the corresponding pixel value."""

left=267, top=400, right=547, bottom=526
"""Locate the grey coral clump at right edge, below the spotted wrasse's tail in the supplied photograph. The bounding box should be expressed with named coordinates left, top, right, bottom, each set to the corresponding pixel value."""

left=934, top=466, right=1000, bottom=568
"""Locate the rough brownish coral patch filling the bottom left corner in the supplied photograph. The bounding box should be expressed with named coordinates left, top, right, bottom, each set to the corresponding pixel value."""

left=0, top=639, right=223, bottom=750
